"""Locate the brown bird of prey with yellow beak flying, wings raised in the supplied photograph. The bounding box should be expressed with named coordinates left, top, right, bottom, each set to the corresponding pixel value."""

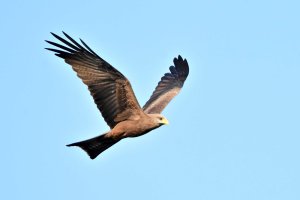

left=46, top=32, right=189, bottom=159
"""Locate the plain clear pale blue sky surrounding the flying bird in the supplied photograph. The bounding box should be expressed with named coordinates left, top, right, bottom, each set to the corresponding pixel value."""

left=0, top=0, right=300, bottom=200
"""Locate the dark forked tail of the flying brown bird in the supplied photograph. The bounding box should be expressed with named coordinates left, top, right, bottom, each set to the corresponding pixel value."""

left=67, top=134, right=120, bottom=159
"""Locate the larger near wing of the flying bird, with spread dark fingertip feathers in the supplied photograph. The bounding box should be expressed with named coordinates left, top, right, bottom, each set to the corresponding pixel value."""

left=46, top=32, right=142, bottom=128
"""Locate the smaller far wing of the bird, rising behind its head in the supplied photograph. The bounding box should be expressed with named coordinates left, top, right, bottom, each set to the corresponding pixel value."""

left=143, top=55, right=189, bottom=114
